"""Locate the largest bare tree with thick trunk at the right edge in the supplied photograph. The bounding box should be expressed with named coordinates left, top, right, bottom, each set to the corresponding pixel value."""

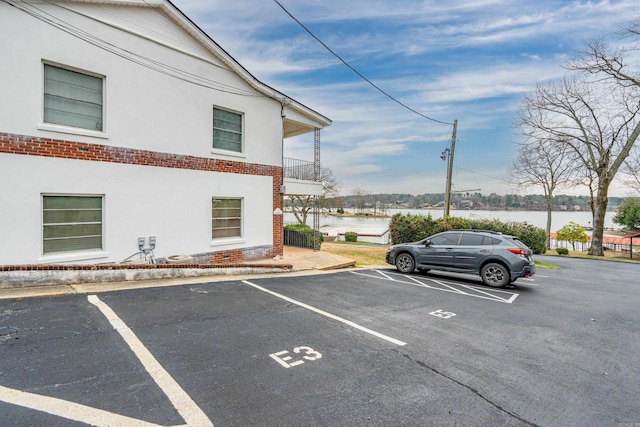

left=519, top=78, right=640, bottom=256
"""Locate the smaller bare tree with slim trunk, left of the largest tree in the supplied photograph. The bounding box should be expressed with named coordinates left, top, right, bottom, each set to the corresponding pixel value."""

left=510, top=137, right=577, bottom=249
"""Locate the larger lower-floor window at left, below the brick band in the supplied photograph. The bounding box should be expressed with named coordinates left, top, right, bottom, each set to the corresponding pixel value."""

left=42, top=196, right=102, bottom=255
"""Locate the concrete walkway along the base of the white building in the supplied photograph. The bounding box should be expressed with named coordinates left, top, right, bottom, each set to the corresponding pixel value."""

left=0, top=246, right=355, bottom=299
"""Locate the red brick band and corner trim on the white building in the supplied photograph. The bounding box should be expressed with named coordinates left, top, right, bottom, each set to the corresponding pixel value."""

left=0, top=133, right=283, bottom=263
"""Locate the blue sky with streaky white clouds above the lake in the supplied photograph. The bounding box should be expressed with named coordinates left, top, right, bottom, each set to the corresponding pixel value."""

left=173, top=0, right=640, bottom=196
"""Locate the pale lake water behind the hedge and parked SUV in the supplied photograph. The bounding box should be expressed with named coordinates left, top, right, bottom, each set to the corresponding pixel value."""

left=284, top=209, right=620, bottom=235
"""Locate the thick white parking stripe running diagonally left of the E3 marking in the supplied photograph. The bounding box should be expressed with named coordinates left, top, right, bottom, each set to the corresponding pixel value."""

left=88, top=295, right=213, bottom=427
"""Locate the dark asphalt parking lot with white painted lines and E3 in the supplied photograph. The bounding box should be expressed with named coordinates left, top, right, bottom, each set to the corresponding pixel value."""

left=0, top=258, right=640, bottom=426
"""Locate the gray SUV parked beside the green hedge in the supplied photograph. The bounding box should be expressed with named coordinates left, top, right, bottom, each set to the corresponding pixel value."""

left=386, top=230, right=536, bottom=288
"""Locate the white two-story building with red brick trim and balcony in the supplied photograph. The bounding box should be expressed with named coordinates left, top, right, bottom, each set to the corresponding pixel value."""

left=0, top=0, right=331, bottom=265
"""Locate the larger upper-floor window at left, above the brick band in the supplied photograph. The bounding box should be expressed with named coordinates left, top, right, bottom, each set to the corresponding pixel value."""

left=44, top=64, right=103, bottom=131
